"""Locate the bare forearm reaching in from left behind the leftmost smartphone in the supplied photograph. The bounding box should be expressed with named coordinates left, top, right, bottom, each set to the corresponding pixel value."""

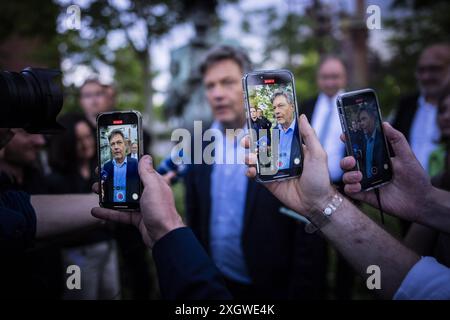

left=31, top=194, right=101, bottom=239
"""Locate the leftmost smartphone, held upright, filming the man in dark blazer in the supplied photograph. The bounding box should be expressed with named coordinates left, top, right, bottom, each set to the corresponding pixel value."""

left=97, top=111, right=143, bottom=211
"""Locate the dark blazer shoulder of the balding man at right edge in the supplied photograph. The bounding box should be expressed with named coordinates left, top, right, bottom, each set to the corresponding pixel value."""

left=392, top=93, right=419, bottom=141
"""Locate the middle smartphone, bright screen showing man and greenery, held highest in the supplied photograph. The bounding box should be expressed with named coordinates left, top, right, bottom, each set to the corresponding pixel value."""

left=242, top=70, right=303, bottom=182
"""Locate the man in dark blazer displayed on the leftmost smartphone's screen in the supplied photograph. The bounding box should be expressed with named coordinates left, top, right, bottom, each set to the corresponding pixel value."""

left=102, top=130, right=139, bottom=202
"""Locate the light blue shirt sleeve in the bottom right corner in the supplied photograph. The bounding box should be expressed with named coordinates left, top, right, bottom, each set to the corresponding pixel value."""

left=394, top=257, right=450, bottom=300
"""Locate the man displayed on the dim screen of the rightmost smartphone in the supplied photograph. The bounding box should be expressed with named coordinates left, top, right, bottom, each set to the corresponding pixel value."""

left=358, top=107, right=384, bottom=179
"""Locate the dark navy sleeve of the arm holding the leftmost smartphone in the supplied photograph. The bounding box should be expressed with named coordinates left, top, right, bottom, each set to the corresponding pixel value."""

left=152, top=228, right=232, bottom=300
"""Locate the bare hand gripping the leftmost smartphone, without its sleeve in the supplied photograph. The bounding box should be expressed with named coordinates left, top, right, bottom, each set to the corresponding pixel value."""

left=92, top=155, right=184, bottom=248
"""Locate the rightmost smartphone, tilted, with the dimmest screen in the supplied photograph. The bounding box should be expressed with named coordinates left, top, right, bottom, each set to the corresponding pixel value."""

left=336, top=89, right=392, bottom=191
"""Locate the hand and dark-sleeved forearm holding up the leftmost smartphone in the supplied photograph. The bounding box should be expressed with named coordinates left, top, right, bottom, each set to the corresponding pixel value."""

left=92, top=156, right=231, bottom=299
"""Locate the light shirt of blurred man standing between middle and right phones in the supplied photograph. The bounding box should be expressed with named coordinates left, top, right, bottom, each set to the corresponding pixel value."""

left=311, top=91, right=345, bottom=181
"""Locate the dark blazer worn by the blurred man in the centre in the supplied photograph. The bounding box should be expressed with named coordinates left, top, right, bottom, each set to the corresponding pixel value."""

left=185, top=141, right=327, bottom=299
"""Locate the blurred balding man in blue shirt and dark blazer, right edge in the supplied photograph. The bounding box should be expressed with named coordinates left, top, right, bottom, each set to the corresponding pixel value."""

left=392, top=43, right=450, bottom=170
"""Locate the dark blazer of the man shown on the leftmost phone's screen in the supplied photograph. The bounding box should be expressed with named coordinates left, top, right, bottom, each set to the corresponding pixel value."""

left=102, top=156, right=140, bottom=202
